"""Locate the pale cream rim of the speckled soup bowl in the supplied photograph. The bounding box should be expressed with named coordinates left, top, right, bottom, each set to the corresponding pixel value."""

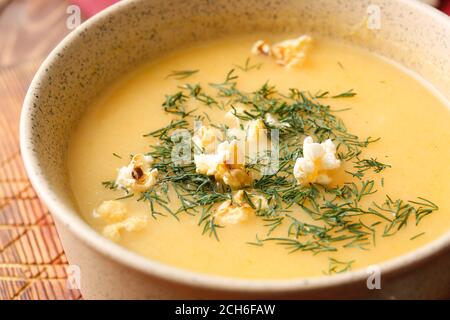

left=20, top=0, right=450, bottom=294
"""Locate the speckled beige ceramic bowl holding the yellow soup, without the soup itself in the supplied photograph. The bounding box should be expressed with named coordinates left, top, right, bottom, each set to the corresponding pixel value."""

left=20, top=0, right=450, bottom=299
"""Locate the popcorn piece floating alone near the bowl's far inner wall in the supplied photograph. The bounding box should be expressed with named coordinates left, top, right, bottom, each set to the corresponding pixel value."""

left=251, top=35, right=312, bottom=68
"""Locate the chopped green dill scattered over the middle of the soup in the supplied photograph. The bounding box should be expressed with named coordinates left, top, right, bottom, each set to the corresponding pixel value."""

left=103, top=68, right=438, bottom=274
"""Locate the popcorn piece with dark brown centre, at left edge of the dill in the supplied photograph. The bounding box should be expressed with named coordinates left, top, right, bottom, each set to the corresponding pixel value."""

left=116, top=153, right=158, bottom=192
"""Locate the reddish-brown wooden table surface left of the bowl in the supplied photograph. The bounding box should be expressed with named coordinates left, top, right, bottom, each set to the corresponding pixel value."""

left=0, top=0, right=81, bottom=299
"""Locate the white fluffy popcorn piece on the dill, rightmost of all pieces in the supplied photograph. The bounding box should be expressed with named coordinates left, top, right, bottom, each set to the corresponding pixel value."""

left=294, top=137, right=341, bottom=185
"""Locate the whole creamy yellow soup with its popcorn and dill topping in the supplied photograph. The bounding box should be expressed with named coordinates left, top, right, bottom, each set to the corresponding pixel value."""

left=68, top=36, right=450, bottom=279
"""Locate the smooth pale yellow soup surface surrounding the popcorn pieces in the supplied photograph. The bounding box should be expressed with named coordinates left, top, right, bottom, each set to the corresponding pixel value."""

left=68, top=35, right=450, bottom=279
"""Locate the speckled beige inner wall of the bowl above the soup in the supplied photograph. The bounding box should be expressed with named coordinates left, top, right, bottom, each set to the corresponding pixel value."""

left=21, top=0, right=450, bottom=292
